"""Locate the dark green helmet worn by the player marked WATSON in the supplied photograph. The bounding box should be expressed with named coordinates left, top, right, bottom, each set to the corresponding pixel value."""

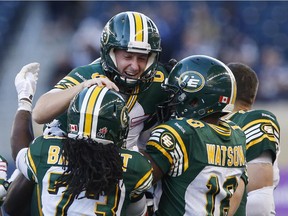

left=164, top=55, right=236, bottom=119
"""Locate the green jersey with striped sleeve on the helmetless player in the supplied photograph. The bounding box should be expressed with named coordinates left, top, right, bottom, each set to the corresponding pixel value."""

left=225, top=110, right=280, bottom=216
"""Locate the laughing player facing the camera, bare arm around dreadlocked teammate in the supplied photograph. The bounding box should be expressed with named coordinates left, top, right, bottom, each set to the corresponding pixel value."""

left=32, top=11, right=167, bottom=149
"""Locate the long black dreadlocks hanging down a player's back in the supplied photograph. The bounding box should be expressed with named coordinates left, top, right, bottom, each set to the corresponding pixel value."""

left=56, top=137, right=123, bottom=199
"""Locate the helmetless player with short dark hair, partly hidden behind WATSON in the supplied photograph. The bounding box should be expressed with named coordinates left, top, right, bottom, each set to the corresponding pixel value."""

left=226, top=62, right=280, bottom=216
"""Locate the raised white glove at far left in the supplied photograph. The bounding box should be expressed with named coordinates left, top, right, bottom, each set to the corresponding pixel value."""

left=15, top=62, right=40, bottom=112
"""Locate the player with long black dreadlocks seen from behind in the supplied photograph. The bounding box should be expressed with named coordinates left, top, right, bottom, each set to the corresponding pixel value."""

left=4, top=65, right=152, bottom=215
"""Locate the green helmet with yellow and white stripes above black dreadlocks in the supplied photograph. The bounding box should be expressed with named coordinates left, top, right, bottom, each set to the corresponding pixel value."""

left=67, top=85, right=129, bottom=148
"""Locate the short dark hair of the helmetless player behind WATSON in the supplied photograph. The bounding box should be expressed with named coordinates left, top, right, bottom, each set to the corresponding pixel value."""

left=227, top=62, right=259, bottom=105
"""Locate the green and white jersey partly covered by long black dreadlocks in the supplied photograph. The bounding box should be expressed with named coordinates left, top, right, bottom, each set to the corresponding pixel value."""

left=21, top=136, right=152, bottom=216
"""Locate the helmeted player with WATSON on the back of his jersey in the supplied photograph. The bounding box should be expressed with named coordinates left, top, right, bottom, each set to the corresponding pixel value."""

left=143, top=55, right=247, bottom=216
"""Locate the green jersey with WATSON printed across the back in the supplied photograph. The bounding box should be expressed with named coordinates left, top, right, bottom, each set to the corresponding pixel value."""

left=146, top=118, right=247, bottom=216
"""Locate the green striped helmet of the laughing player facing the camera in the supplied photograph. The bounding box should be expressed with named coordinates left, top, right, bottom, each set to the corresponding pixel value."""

left=100, top=11, right=162, bottom=94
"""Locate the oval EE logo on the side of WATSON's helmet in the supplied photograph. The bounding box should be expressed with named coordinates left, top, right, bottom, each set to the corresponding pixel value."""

left=178, top=71, right=205, bottom=92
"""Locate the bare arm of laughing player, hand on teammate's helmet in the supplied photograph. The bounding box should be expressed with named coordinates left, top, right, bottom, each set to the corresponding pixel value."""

left=32, top=77, right=119, bottom=124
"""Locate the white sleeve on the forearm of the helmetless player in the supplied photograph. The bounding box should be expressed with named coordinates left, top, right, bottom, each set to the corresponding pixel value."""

left=246, top=186, right=276, bottom=216
